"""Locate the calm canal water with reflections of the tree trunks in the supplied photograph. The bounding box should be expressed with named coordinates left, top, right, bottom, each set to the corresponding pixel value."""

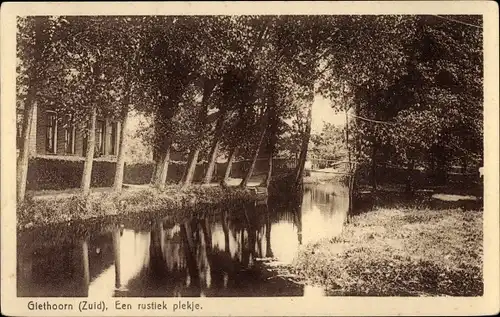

left=17, top=184, right=348, bottom=297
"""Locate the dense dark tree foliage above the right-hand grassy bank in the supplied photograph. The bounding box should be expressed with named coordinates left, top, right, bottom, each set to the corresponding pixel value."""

left=316, top=16, right=483, bottom=186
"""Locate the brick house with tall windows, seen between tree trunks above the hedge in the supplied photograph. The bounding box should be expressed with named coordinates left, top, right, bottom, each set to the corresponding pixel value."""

left=17, top=105, right=121, bottom=162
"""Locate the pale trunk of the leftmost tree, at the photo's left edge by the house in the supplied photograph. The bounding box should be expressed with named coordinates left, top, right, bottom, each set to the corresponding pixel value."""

left=16, top=92, right=35, bottom=202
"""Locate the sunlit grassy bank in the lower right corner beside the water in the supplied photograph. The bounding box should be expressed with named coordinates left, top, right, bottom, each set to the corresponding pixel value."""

left=292, top=207, right=483, bottom=296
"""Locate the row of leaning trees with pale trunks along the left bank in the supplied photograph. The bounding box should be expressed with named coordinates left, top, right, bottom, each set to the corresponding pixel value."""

left=17, top=16, right=317, bottom=199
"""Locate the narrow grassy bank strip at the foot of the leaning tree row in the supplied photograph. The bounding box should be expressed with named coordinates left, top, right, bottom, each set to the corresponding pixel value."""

left=17, top=185, right=257, bottom=230
